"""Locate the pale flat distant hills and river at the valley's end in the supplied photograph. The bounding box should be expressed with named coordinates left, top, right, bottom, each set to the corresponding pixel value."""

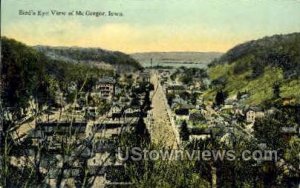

left=130, top=52, right=222, bottom=64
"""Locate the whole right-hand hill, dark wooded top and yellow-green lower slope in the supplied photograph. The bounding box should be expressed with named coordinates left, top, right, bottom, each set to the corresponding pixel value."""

left=206, top=33, right=300, bottom=105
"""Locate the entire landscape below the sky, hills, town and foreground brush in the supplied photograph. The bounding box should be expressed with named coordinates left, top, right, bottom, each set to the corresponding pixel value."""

left=1, top=33, right=300, bottom=187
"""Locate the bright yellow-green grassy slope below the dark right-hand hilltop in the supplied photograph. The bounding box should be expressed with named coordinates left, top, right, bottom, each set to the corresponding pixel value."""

left=204, top=60, right=300, bottom=105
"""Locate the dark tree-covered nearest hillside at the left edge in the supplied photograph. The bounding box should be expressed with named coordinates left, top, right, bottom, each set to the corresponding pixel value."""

left=1, top=37, right=112, bottom=117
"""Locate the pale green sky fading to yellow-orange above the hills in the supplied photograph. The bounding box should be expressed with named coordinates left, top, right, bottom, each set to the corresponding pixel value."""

left=1, top=0, right=300, bottom=53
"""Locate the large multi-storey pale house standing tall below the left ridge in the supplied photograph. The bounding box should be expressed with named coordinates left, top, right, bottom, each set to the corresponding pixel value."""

left=95, top=77, right=116, bottom=99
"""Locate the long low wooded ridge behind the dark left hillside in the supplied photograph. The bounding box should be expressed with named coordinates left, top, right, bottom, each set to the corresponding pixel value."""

left=34, top=46, right=141, bottom=71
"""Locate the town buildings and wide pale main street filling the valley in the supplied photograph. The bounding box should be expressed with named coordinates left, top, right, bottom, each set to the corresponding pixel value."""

left=4, top=60, right=297, bottom=187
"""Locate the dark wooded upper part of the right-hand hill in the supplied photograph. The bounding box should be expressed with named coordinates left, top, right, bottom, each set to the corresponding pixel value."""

left=211, top=33, right=300, bottom=76
